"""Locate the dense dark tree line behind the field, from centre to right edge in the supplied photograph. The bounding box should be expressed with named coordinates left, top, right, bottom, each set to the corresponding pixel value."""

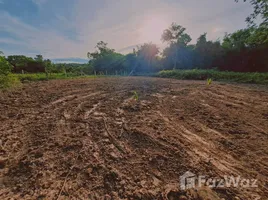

left=88, top=23, right=268, bottom=73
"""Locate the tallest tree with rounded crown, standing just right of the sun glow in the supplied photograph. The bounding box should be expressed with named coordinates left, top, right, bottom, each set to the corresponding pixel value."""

left=161, top=23, right=192, bottom=69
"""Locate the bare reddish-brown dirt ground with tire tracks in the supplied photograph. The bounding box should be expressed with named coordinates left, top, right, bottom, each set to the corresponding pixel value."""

left=0, top=77, right=268, bottom=200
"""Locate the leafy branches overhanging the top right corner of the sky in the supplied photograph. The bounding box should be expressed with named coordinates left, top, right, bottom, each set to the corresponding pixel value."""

left=235, top=0, right=268, bottom=26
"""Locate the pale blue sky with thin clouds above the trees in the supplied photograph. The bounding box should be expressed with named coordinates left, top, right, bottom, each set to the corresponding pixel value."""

left=0, top=0, right=252, bottom=62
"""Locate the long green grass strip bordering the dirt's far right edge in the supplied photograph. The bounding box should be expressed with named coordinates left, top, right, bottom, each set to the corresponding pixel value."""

left=157, top=69, right=268, bottom=84
